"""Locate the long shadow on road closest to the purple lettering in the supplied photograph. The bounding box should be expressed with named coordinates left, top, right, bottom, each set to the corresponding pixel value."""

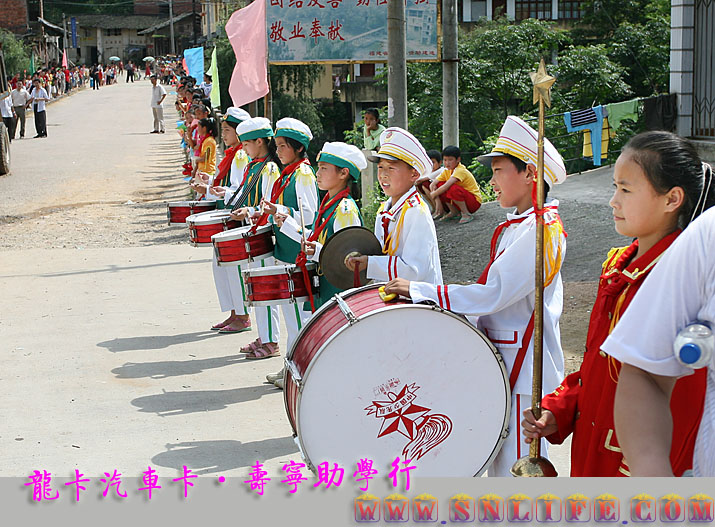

left=151, top=437, right=298, bottom=474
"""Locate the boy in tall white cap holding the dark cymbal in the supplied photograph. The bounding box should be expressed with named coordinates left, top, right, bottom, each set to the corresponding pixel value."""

left=346, top=127, right=442, bottom=284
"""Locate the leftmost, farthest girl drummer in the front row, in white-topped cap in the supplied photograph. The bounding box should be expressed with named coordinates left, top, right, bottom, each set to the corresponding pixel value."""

left=192, top=107, right=251, bottom=333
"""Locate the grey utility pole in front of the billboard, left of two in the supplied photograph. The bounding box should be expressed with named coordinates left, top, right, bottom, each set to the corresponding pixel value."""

left=387, top=0, right=407, bottom=129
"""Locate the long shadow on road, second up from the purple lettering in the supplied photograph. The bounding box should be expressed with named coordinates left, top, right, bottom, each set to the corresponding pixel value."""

left=132, top=384, right=281, bottom=417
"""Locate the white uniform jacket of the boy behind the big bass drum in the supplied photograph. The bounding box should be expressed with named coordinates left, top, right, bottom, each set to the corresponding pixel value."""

left=410, top=200, right=566, bottom=394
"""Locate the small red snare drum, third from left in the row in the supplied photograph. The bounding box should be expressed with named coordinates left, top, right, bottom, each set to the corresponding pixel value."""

left=211, top=225, right=274, bottom=265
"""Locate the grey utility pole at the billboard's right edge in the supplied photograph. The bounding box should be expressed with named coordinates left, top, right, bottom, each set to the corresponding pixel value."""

left=442, top=0, right=459, bottom=148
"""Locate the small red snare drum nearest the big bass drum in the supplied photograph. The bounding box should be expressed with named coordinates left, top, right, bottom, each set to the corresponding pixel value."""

left=243, top=262, right=319, bottom=307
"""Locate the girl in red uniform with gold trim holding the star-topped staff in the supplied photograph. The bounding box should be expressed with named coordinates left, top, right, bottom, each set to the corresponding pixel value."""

left=522, top=131, right=715, bottom=477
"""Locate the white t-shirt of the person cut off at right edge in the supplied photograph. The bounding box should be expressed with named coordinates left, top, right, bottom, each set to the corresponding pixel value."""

left=602, top=208, right=715, bottom=477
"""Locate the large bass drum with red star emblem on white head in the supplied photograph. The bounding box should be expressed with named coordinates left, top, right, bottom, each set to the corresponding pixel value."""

left=284, top=284, right=511, bottom=477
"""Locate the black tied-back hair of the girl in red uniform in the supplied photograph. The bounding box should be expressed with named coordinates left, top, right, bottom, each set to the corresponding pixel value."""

left=622, top=130, right=715, bottom=228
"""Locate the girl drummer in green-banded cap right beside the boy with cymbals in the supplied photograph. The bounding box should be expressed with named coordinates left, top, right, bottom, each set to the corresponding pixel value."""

left=266, top=143, right=367, bottom=389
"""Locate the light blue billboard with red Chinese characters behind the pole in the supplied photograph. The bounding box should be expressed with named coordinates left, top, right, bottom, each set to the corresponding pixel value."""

left=266, top=0, right=439, bottom=63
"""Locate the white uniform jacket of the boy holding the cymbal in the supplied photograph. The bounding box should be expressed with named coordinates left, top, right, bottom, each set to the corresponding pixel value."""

left=367, top=189, right=442, bottom=284
